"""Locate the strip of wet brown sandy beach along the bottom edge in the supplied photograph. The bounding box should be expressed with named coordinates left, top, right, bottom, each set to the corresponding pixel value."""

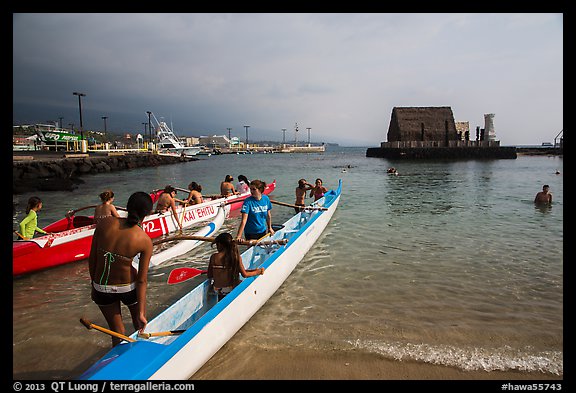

left=191, top=346, right=563, bottom=381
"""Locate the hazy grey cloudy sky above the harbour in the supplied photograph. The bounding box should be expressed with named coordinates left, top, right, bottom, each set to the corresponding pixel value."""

left=13, top=13, right=564, bottom=146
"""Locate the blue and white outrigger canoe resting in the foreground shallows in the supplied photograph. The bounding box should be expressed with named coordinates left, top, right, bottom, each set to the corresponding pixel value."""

left=79, top=180, right=342, bottom=380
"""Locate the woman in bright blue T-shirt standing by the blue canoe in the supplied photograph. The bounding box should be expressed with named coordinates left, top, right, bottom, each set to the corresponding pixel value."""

left=236, top=180, right=274, bottom=240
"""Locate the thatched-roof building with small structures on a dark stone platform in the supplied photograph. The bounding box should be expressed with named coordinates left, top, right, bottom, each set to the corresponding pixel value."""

left=366, top=106, right=516, bottom=158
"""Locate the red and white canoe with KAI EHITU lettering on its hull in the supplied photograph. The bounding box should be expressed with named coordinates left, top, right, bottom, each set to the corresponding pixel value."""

left=12, top=180, right=276, bottom=276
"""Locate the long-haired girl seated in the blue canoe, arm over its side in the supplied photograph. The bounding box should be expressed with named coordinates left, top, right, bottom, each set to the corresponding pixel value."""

left=207, top=232, right=265, bottom=300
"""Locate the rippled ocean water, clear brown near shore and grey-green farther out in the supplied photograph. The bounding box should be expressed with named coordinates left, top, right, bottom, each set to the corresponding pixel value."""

left=12, top=148, right=564, bottom=379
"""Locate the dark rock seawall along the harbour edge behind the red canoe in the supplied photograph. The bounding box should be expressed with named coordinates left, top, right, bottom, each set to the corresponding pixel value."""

left=12, top=153, right=197, bottom=194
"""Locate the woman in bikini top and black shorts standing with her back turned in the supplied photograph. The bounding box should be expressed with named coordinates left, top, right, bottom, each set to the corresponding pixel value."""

left=88, top=191, right=153, bottom=346
